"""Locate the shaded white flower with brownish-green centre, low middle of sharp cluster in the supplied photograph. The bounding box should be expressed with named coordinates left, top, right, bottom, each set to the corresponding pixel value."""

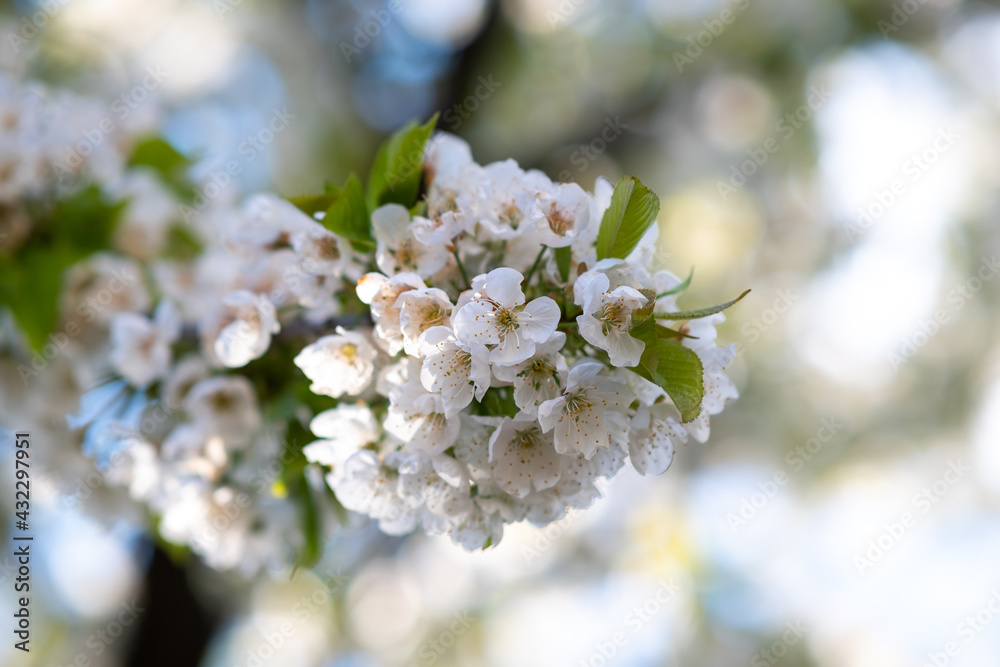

left=490, top=415, right=563, bottom=498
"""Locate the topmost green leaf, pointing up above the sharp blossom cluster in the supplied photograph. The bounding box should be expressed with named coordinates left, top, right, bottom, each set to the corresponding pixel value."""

left=368, top=114, right=438, bottom=210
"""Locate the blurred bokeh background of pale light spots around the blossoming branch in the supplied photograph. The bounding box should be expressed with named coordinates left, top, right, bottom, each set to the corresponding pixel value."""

left=0, top=0, right=1000, bottom=667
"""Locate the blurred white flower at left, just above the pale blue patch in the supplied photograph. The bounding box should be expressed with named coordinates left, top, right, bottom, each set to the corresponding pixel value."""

left=110, top=301, right=181, bottom=388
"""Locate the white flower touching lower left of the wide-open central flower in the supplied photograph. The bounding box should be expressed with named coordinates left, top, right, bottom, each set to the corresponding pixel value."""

left=420, top=327, right=490, bottom=418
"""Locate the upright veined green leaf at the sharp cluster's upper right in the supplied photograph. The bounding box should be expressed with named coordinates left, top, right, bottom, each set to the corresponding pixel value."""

left=597, top=176, right=660, bottom=260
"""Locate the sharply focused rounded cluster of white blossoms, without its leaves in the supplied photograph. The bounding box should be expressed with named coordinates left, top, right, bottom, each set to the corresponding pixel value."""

left=295, top=134, right=736, bottom=549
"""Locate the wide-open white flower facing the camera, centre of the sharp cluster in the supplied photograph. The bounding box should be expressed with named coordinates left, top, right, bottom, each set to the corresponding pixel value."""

left=454, top=267, right=559, bottom=366
